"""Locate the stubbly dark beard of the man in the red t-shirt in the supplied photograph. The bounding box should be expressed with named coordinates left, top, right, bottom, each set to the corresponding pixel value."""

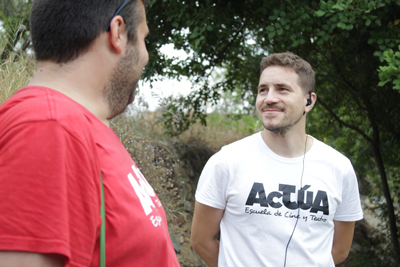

left=104, top=45, right=143, bottom=120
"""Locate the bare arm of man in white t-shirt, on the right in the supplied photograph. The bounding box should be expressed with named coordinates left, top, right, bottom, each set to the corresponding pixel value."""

left=332, top=220, right=355, bottom=265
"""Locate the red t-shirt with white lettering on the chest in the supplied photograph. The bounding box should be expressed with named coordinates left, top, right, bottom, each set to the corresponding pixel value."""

left=0, top=87, right=179, bottom=267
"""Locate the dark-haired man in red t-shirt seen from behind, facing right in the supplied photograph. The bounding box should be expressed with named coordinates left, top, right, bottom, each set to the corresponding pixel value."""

left=0, top=0, right=179, bottom=267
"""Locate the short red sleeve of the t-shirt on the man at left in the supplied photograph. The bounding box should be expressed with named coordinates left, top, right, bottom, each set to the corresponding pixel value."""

left=0, top=120, right=101, bottom=266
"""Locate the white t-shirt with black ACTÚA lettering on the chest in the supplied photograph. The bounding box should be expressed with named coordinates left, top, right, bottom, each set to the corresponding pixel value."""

left=196, top=133, right=363, bottom=267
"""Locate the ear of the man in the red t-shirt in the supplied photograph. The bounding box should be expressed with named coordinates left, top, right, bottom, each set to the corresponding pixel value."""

left=108, top=15, right=128, bottom=54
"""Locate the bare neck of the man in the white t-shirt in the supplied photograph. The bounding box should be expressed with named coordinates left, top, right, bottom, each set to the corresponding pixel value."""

left=261, top=129, right=313, bottom=158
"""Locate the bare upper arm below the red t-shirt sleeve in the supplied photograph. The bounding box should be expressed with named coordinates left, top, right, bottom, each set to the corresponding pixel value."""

left=0, top=251, right=64, bottom=267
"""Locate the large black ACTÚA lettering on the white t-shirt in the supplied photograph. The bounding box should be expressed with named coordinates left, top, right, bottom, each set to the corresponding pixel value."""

left=246, top=183, right=329, bottom=215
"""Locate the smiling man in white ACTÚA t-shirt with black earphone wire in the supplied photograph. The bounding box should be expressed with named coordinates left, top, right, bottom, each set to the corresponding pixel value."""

left=191, top=52, right=363, bottom=267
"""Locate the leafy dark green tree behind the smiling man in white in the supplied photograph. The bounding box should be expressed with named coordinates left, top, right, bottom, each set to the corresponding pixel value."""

left=149, top=0, right=400, bottom=262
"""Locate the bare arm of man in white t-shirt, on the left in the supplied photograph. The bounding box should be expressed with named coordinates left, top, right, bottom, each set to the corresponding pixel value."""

left=190, top=201, right=224, bottom=267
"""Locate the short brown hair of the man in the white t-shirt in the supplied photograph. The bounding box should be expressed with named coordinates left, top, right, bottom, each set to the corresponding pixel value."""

left=260, top=52, right=315, bottom=93
